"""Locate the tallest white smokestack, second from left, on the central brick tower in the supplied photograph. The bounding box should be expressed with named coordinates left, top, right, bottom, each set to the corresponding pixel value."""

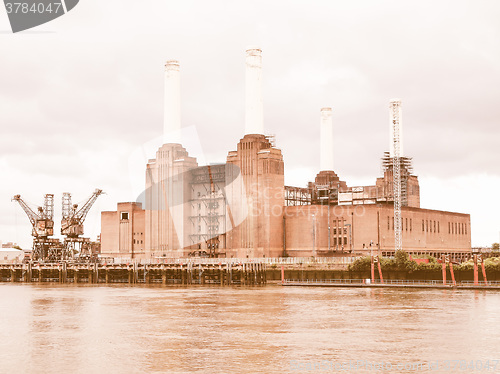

left=245, top=47, right=264, bottom=134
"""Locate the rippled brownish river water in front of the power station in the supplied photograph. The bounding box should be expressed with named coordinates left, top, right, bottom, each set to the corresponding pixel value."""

left=0, top=284, right=500, bottom=374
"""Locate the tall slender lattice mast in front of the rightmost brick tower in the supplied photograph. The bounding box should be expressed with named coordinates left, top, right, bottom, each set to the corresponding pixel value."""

left=389, top=99, right=403, bottom=251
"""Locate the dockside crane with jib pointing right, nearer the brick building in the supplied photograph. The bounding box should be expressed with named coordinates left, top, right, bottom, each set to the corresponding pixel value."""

left=61, top=189, right=103, bottom=259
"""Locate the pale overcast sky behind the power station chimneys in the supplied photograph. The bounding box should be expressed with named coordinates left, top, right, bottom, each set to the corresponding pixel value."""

left=0, top=0, right=500, bottom=247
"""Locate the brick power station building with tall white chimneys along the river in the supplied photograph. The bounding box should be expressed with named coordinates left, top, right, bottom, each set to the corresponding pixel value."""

left=101, top=48, right=471, bottom=258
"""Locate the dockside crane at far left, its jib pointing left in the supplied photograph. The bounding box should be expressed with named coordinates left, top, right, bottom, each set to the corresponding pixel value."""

left=12, top=194, right=63, bottom=261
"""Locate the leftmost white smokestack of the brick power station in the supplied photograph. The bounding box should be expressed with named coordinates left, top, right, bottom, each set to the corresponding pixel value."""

left=163, top=60, right=181, bottom=143
